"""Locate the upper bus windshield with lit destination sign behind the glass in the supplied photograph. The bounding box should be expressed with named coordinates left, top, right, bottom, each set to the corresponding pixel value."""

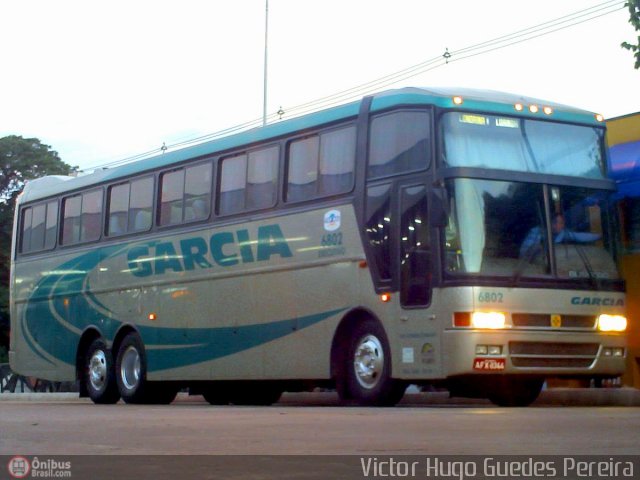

left=442, top=112, right=606, bottom=179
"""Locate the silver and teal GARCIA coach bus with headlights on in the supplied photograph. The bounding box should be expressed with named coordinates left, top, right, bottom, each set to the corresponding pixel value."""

left=9, top=88, right=627, bottom=406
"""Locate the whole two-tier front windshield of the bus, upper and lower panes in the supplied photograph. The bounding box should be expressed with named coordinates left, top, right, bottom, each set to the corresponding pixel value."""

left=443, top=112, right=620, bottom=284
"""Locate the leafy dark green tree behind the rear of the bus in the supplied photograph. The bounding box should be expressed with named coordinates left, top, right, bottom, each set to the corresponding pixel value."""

left=0, top=135, right=74, bottom=347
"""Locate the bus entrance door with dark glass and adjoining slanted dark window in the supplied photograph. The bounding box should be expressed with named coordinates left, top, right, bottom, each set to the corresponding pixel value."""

left=365, top=178, right=440, bottom=378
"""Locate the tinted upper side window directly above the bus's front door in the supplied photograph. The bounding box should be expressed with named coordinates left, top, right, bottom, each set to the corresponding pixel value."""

left=367, top=111, right=430, bottom=178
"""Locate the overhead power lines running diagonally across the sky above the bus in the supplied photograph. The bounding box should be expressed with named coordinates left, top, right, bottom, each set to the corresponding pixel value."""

left=80, top=0, right=624, bottom=170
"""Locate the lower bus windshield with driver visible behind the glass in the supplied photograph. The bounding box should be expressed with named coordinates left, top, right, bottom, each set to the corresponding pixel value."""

left=445, top=182, right=620, bottom=281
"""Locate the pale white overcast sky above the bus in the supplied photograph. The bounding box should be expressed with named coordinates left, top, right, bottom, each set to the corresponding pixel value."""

left=0, top=0, right=640, bottom=170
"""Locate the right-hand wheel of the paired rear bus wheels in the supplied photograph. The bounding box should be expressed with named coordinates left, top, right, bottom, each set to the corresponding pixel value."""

left=115, top=333, right=178, bottom=405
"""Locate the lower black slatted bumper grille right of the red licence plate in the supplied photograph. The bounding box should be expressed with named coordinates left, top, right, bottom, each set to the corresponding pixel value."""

left=509, top=342, right=600, bottom=368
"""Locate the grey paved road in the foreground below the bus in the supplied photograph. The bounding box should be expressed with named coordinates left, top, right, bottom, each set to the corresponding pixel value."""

left=0, top=394, right=640, bottom=455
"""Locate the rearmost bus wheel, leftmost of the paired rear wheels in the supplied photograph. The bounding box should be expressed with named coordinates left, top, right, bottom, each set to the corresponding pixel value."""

left=82, top=338, right=120, bottom=404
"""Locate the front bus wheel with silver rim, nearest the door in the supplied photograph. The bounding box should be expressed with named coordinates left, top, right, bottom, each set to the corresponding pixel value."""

left=337, top=319, right=406, bottom=406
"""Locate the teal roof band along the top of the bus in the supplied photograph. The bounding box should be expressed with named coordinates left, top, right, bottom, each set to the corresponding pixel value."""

left=20, top=87, right=604, bottom=203
